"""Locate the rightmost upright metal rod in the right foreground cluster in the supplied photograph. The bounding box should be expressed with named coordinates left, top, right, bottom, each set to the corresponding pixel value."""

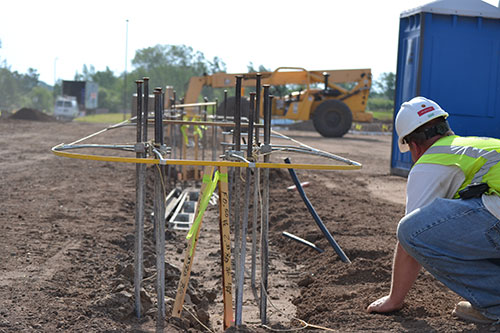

left=260, top=84, right=271, bottom=324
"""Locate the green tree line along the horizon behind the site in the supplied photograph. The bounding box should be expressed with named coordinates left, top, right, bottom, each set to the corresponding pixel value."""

left=0, top=41, right=394, bottom=113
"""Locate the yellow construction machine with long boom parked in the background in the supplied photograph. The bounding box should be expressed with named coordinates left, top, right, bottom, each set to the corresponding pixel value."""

left=184, top=67, right=372, bottom=137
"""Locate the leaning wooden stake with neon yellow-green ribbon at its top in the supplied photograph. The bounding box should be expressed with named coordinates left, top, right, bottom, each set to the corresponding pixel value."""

left=172, top=167, right=215, bottom=318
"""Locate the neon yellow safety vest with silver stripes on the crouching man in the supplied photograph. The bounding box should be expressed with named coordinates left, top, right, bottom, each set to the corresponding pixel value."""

left=415, top=135, right=500, bottom=198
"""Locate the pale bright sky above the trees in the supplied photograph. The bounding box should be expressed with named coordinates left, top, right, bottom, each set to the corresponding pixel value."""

left=0, top=0, right=498, bottom=85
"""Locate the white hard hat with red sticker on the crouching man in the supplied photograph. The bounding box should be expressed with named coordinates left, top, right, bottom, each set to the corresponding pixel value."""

left=396, top=96, right=448, bottom=153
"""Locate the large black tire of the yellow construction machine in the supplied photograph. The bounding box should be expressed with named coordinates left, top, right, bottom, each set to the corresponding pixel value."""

left=313, top=99, right=352, bottom=138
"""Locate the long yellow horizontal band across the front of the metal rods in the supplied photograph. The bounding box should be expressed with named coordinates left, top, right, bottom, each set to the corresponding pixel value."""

left=52, top=146, right=361, bottom=170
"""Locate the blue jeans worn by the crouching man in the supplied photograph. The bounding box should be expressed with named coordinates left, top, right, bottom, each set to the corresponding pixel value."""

left=398, top=198, right=500, bottom=319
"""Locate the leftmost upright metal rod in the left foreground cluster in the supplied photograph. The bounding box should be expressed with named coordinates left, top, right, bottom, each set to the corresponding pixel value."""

left=134, top=80, right=145, bottom=318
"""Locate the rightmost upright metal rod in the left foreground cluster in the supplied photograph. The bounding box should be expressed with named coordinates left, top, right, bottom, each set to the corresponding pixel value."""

left=154, top=88, right=165, bottom=326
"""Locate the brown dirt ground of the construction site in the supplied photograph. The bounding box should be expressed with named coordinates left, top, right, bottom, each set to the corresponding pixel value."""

left=0, top=113, right=500, bottom=332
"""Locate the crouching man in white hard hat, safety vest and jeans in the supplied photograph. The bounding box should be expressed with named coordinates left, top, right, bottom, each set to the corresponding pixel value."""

left=367, top=97, right=500, bottom=323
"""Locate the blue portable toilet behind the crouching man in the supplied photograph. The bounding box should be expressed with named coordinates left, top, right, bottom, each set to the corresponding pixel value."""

left=391, top=0, right=500, bottom=176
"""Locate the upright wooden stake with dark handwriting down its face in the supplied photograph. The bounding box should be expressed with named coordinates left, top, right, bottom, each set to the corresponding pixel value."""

left=219, top=167, right=234, bottom=330
